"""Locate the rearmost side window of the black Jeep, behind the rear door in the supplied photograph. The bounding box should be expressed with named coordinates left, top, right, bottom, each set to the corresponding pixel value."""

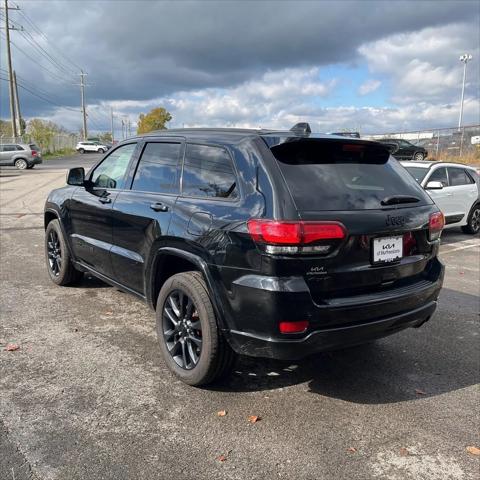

left=182, top=145, right=238, bottom=198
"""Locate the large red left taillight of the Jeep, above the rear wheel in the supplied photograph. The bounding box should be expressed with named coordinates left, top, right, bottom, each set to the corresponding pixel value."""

left=247, top=219, right=347, bottom=254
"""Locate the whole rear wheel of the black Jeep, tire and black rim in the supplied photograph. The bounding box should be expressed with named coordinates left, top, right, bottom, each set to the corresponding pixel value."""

left=156, top=272, right=235, bottom=386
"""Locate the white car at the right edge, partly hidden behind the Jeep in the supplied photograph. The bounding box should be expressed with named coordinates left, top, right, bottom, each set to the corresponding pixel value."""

left=400, top=162, right=480, bottom=234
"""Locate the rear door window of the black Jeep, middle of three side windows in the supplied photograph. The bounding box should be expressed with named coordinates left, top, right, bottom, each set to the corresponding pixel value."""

left=132, top=143, right=181, bottom=193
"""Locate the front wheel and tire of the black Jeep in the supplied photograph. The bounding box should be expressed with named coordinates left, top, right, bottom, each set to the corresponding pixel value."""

left=45, top=220, right=83, bottom=286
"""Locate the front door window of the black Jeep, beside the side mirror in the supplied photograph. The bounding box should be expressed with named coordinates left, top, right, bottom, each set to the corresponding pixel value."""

left=91, top=143, right=137, bottom=188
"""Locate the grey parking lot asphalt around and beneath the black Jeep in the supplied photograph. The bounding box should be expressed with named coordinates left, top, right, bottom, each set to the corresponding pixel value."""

left=0, top=155, right=480, bottom=480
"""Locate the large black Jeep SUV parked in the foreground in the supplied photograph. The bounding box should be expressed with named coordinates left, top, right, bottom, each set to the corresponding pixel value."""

left=45, top=126, right=444, bottom=385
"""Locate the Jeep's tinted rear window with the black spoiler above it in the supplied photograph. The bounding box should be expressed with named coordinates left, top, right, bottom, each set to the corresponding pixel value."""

left=271, top=139, right=432, bottom=210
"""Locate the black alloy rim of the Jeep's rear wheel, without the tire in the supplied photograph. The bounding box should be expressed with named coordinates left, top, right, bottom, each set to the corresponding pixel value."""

left=162, top=290, right=202, bottom=370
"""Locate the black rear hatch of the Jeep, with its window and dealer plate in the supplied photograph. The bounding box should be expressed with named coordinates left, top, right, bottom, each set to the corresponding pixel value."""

left=263, top=137, right=438, bottom=304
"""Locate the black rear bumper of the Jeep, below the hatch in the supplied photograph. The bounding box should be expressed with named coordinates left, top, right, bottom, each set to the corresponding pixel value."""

left=225, top=258, right=444, bottom=360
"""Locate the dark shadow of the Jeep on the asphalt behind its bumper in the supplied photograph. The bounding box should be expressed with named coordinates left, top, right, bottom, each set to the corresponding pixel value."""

left=210, top=289, right=480, bottom=404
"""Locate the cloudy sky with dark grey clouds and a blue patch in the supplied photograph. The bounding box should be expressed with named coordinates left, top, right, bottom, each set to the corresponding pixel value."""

left=0, top=0, right=480, bottom=135
